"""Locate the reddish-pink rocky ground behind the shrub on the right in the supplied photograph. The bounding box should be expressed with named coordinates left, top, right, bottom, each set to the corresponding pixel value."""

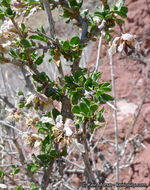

left=89, top=0, right=150, bottom=190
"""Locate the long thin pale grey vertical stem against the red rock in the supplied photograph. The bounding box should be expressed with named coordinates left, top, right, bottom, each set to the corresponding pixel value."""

left=110, top=54, right=119, bottom=190
